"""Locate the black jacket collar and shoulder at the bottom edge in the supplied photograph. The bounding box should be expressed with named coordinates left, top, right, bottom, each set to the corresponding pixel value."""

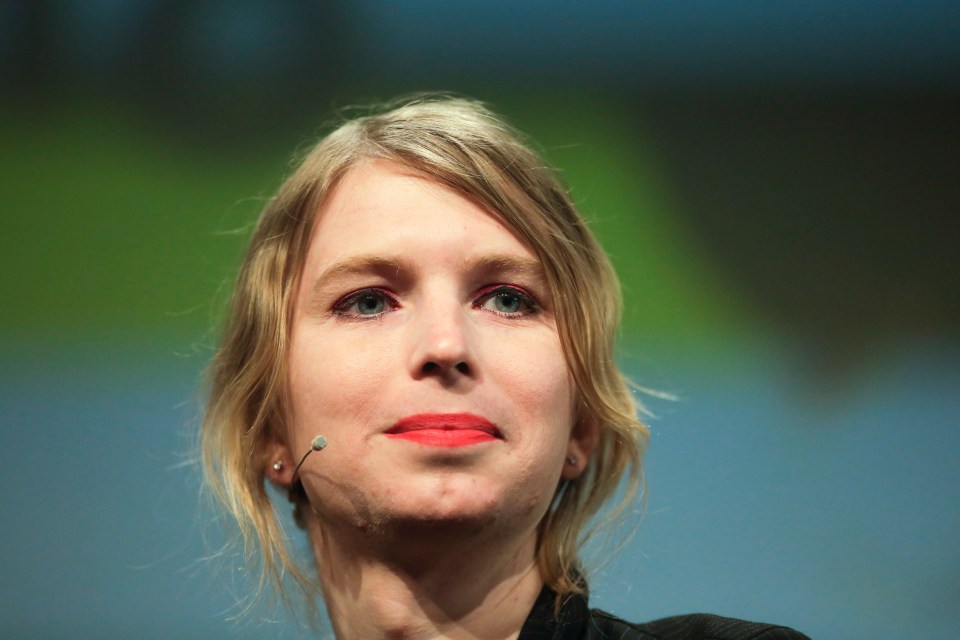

left=518, top=587, right=810, bottom=640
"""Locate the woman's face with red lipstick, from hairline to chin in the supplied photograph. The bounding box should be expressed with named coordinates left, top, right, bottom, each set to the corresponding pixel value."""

left=281, top=162, right=591, bottom=534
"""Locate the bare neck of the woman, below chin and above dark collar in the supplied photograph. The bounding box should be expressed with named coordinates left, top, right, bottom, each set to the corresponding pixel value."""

left=310, top=520, right=543, bottom=640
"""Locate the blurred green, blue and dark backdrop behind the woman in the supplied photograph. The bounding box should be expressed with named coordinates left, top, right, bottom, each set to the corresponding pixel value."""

left=0, top=0, right=960, bottom=639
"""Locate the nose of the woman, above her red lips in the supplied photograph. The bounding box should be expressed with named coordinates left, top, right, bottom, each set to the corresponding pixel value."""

left=410, top=302, right=478, bottom=384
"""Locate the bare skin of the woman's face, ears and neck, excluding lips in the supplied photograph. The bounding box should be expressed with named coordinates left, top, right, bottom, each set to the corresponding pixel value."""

left=267, top=161, right=596, bottom=638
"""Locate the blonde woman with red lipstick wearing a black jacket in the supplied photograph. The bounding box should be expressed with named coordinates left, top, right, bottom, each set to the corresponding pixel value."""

left=202, top=98, right=802, bottom=638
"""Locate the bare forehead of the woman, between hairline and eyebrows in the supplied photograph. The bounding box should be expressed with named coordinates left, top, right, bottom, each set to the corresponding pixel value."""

left=305, top=161, right=536, bottom=271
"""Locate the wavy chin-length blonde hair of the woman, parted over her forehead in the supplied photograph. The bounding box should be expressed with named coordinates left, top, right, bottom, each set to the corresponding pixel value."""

left=200, top=97, right=649, bottom=602
